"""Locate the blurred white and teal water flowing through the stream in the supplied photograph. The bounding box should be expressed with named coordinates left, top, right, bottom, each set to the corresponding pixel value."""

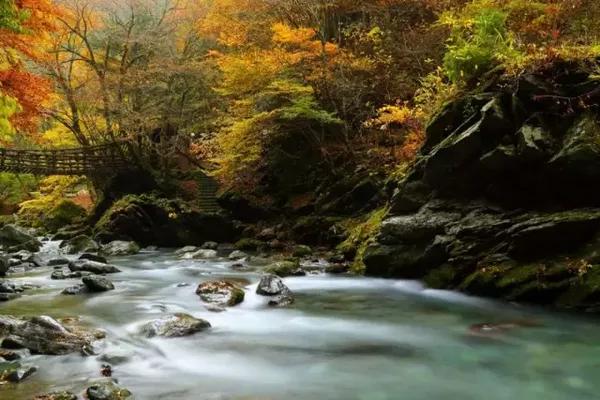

left=0, top=245, right=600, bottom=400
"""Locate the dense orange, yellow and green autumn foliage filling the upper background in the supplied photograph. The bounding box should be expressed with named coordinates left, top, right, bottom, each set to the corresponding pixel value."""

left=0, top=0, right=600, bottom=219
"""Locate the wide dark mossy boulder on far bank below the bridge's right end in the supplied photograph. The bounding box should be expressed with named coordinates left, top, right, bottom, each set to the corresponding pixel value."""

left=94, top=194, right=238, bottom=247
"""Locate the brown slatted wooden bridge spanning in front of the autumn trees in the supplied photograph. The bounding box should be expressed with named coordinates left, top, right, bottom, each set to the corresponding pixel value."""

left=0, top=141, right=135, bottom=175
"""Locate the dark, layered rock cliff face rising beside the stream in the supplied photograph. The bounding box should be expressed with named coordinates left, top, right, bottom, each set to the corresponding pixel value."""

left=364, top=62, right=600, bottom=308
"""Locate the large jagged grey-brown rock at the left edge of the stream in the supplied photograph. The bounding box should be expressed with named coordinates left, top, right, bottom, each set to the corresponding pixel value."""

left=0, top=315, right=103, bottom=355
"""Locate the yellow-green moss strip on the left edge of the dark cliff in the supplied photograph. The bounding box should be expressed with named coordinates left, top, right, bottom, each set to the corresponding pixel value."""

left=337, top=207, right=388, bottom=274
